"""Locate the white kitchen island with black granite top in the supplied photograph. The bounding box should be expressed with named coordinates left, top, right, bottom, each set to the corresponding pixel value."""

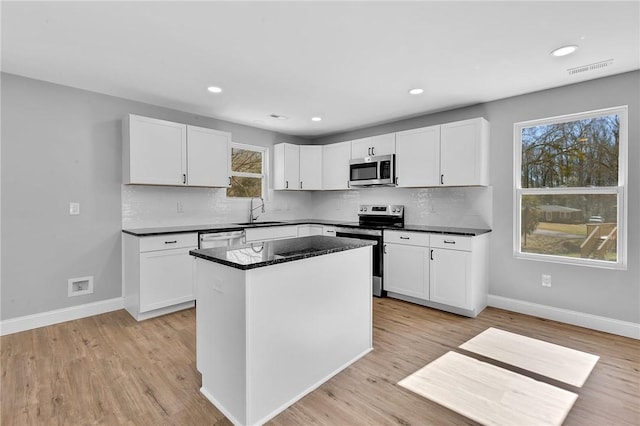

left=190, top=236, right=374, bottom=425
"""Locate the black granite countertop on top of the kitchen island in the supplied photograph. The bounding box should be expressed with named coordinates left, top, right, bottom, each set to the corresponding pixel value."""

left=189, top=235, right=376, bottom=270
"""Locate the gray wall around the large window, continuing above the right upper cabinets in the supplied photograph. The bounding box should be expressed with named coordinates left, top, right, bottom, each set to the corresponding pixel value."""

left=314, top=71, right=640, bottom=323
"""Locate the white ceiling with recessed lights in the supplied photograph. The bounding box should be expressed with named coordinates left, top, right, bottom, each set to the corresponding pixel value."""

left=1, top=1, right=640, bottom=137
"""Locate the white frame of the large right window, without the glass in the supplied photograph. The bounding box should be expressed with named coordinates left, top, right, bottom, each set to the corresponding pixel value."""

left=513, top=105, right=629, bottom=270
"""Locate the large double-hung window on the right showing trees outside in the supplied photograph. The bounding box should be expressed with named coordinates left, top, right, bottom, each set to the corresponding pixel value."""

left=514, top=107, right=627, bottom=269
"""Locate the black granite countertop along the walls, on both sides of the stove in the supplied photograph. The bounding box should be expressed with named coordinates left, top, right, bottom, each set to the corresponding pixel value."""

left=122, top=219, right=491, bottom=237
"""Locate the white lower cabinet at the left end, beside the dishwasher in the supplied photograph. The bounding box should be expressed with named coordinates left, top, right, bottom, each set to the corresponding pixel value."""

left=123, top=233, right=198, bottom=321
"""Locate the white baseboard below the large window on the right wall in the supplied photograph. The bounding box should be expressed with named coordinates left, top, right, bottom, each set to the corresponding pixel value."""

left=488, top=294, right=640, bottom=339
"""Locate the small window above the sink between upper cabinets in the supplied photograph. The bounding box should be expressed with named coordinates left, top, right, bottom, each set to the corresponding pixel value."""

left=227, top=142, right=267, bottom=197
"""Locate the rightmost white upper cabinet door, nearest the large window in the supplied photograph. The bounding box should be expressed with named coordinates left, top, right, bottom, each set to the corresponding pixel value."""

left=440, top=118, right=489, bottom=186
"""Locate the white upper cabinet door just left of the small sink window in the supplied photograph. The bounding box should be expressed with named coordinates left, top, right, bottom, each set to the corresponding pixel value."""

left=187, top=126, right=231, bottom=187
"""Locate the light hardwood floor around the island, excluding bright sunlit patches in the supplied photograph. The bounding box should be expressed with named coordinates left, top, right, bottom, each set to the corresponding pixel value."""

left=0, top=299, right=640, bottom=426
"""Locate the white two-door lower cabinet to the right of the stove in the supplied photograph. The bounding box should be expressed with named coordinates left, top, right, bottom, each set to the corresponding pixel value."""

left=383, top=231, right=488, bottom=317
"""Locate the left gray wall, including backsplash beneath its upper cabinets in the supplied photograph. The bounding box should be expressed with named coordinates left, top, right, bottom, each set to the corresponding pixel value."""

left=0, top=74, right=310, bottom=320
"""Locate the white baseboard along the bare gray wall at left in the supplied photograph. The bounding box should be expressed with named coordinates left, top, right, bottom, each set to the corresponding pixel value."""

left=0, top=297, right=124, bottom=336
